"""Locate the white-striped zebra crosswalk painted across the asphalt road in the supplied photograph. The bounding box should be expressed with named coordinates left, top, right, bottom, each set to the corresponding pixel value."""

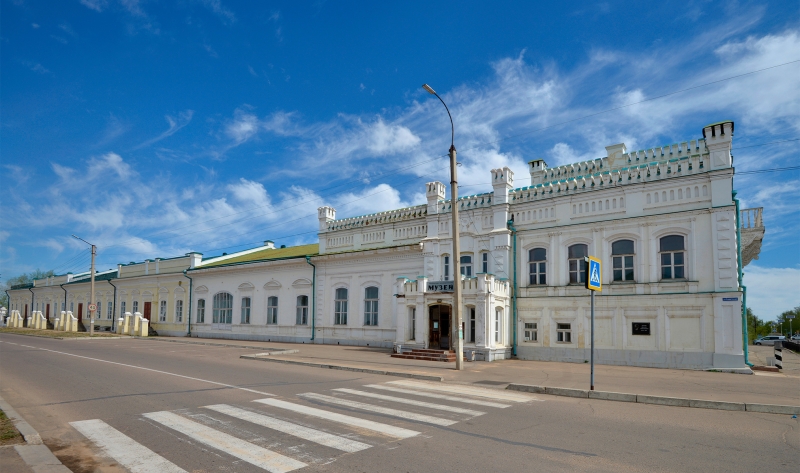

left=70, top=380, right=538, bottom=473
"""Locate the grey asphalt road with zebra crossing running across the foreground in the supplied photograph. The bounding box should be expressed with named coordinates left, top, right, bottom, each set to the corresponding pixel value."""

left=0, top=334, right=800, bottom=472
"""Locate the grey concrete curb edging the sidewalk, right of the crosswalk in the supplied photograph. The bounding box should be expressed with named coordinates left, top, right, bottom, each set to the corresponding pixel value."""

left=506, top=384, right=800, bottom=415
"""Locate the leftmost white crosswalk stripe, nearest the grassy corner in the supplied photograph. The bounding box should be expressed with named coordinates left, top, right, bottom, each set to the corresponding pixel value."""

left=69, top=419, right=186, bottom=473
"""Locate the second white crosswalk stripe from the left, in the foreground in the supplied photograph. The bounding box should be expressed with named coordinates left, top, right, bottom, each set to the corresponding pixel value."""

left=142, top=411, right=307, bottom=473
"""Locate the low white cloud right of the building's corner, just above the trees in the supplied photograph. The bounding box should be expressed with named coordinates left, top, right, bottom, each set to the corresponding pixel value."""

left=743, top=263, right=800, bottom=320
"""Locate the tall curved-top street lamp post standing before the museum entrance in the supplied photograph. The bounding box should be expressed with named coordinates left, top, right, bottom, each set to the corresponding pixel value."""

left=422, top=84, right=464, bottom=370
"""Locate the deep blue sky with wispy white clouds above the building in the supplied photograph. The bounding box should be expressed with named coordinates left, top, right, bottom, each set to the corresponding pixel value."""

left=0, top=0, right=800, bottom=319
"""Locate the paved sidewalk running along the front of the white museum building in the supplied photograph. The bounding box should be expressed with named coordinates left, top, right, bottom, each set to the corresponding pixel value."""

left=141, top=337, right=800, bottom=406
